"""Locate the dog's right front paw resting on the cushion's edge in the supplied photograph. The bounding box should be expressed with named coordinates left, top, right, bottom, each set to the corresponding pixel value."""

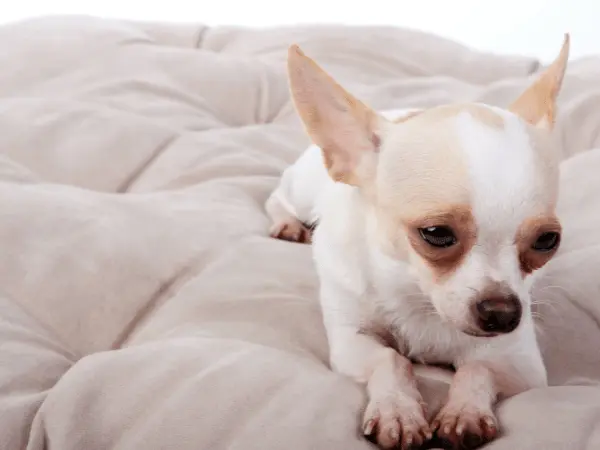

left=431, top=403, right=498, bottom=449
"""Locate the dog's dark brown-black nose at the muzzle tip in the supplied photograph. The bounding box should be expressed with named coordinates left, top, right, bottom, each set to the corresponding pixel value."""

left=475, top=295, right=522, bottom=333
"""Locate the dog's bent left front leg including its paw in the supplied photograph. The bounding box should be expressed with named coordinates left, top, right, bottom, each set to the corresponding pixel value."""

left=328, top=327, right=431, bottom=449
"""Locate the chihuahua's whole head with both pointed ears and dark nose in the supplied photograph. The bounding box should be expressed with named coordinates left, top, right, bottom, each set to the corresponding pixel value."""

left=288, top=35, right=569, bottom=336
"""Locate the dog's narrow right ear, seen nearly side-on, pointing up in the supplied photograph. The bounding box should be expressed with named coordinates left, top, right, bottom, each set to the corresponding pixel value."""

left=508, top=34, right=570, bottom=130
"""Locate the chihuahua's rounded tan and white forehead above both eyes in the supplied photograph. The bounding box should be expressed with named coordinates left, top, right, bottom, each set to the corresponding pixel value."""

left=377, top=104, right=552, bottom=221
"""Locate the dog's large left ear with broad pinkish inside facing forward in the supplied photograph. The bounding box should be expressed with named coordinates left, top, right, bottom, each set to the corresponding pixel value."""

left=288, top=45, right=383, bottom=186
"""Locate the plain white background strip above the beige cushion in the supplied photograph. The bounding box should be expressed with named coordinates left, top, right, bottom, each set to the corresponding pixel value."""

left=0, top=0, right=600, bottom=60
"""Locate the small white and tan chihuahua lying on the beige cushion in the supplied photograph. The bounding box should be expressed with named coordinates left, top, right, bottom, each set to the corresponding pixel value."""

left=266, top=34, right=569, bottom=449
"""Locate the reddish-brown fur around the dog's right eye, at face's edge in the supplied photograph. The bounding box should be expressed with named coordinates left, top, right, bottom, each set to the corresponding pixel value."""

left=515, top=215, right=561, bottom=277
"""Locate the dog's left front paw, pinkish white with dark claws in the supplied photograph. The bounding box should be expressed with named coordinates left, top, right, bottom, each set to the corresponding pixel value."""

left=363, top=394, right=432, bottom=450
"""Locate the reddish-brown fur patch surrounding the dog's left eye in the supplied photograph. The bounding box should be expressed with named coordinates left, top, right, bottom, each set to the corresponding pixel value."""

left=403, top=205, right=477, bottom=282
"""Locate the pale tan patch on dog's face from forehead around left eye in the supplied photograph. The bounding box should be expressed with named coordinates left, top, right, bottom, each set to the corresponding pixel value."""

left=376, top=105, right=479, bottom=264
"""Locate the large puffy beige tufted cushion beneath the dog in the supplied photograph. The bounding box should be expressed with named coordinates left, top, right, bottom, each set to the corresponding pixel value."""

left=0, top=17, right=600, bottom=450
